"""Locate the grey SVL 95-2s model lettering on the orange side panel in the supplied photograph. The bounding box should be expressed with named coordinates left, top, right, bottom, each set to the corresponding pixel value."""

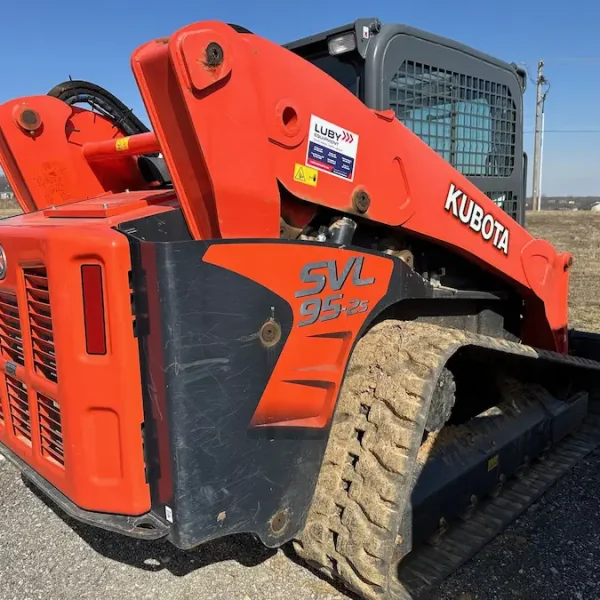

left=295, top=256, right=375, bottom=327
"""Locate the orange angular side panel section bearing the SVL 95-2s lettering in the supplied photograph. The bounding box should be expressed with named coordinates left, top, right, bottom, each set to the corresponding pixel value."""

left=204, top=244, right=393, bottom=428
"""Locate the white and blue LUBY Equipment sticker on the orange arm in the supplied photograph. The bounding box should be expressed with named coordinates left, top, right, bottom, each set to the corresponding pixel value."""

left=306, top=115, right=358, bottom=181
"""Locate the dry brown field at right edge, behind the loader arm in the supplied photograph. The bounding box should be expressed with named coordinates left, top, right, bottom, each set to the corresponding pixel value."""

left=526, top=211, right=600, bottom=331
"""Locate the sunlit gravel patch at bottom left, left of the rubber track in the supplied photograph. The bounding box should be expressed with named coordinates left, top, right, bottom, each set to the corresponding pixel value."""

left=0, top=456, right=346, bottom=600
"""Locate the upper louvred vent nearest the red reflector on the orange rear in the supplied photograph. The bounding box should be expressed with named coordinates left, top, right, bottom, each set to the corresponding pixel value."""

left=23, top=266, right=57, bottom=382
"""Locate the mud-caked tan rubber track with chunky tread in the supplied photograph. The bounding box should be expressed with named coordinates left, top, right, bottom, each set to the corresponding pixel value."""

left=294, top=321, right=600, bottom=600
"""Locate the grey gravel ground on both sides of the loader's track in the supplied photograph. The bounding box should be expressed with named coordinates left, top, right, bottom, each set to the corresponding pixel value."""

left=0, top=452, right=600, bottom=600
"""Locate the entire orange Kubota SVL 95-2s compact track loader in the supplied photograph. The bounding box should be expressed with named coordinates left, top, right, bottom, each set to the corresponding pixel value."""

left=0, top=19, right=600, bottom=600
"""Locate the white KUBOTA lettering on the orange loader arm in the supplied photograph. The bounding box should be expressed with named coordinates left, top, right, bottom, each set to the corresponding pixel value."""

left=444, top=183, right=510, bottom=256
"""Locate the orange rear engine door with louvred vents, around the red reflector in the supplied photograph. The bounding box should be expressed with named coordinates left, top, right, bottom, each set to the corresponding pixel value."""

left=0, top=212, right=156, bottom=515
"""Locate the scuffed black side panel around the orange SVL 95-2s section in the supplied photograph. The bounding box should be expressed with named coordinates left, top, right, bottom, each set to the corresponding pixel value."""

left=124, top=232, right=432, bottom=548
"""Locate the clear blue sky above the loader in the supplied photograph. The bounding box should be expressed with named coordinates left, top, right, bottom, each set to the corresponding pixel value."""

left=0, top=0, right=600, bottom=195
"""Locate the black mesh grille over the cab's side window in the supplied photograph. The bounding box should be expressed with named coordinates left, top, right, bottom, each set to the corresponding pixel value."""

left=390, top=61, right=517, bottom=177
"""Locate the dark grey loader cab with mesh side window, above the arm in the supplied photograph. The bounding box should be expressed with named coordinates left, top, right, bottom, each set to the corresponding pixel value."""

left=285, top=19, right=527, bottom=223
